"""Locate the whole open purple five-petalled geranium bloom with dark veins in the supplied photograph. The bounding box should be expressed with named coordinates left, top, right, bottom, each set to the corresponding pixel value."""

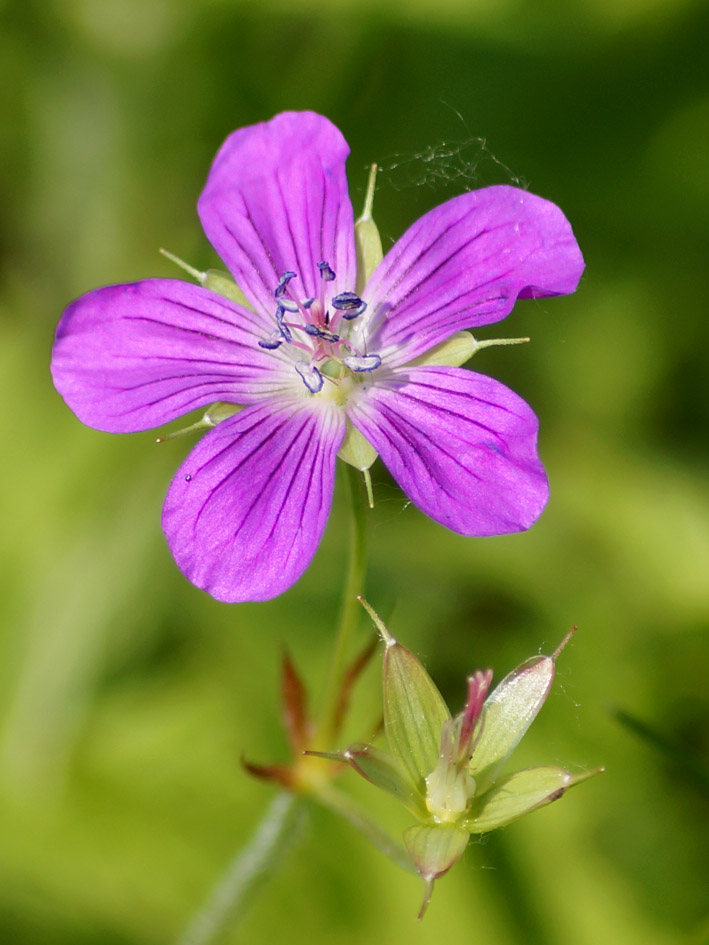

left=52, top=112, right=583, bottom=601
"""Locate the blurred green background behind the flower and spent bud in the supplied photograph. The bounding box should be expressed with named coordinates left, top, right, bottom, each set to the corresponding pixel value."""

left=0, top=0, right=709, bottom=945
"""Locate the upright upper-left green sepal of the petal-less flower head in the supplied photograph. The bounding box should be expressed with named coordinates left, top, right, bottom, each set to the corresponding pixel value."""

left=383, top=637, right=451, bottom=793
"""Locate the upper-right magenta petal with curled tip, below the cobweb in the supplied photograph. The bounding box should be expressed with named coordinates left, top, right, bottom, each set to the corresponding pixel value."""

left=363, top=186, right=584, bottom=366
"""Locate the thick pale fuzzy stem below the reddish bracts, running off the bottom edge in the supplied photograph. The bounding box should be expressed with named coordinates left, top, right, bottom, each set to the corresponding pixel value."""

left=178, top=792, right=301, bottom=945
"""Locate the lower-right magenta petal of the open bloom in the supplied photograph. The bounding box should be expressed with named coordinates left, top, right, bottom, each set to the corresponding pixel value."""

left=348, top=367, right=548, bottom=535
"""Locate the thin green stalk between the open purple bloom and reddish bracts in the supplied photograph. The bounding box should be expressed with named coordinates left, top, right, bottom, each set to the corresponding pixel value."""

left=313, top=463, right=367, bottom=749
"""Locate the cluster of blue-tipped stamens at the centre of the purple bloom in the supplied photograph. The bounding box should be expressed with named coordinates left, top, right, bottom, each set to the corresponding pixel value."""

left=259, top=262, right=382, bottom=394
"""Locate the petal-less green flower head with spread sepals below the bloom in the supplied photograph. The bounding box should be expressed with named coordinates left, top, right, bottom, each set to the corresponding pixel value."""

left=324, top=598, right=603, bottom=918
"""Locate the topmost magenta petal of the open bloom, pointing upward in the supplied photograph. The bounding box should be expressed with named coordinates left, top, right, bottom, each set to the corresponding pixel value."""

left=198, top=112, right=355, bottom=312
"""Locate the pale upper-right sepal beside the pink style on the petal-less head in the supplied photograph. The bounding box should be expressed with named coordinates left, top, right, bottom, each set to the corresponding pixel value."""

left=469, top=656, right=554, bottom=796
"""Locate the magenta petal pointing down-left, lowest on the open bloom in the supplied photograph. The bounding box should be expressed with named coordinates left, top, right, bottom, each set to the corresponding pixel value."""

left=162, top=399, right=345, bottom=603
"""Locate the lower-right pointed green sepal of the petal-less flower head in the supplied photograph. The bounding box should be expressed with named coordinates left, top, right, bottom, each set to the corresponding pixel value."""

left=463, top=765, right=603, bottom=833
